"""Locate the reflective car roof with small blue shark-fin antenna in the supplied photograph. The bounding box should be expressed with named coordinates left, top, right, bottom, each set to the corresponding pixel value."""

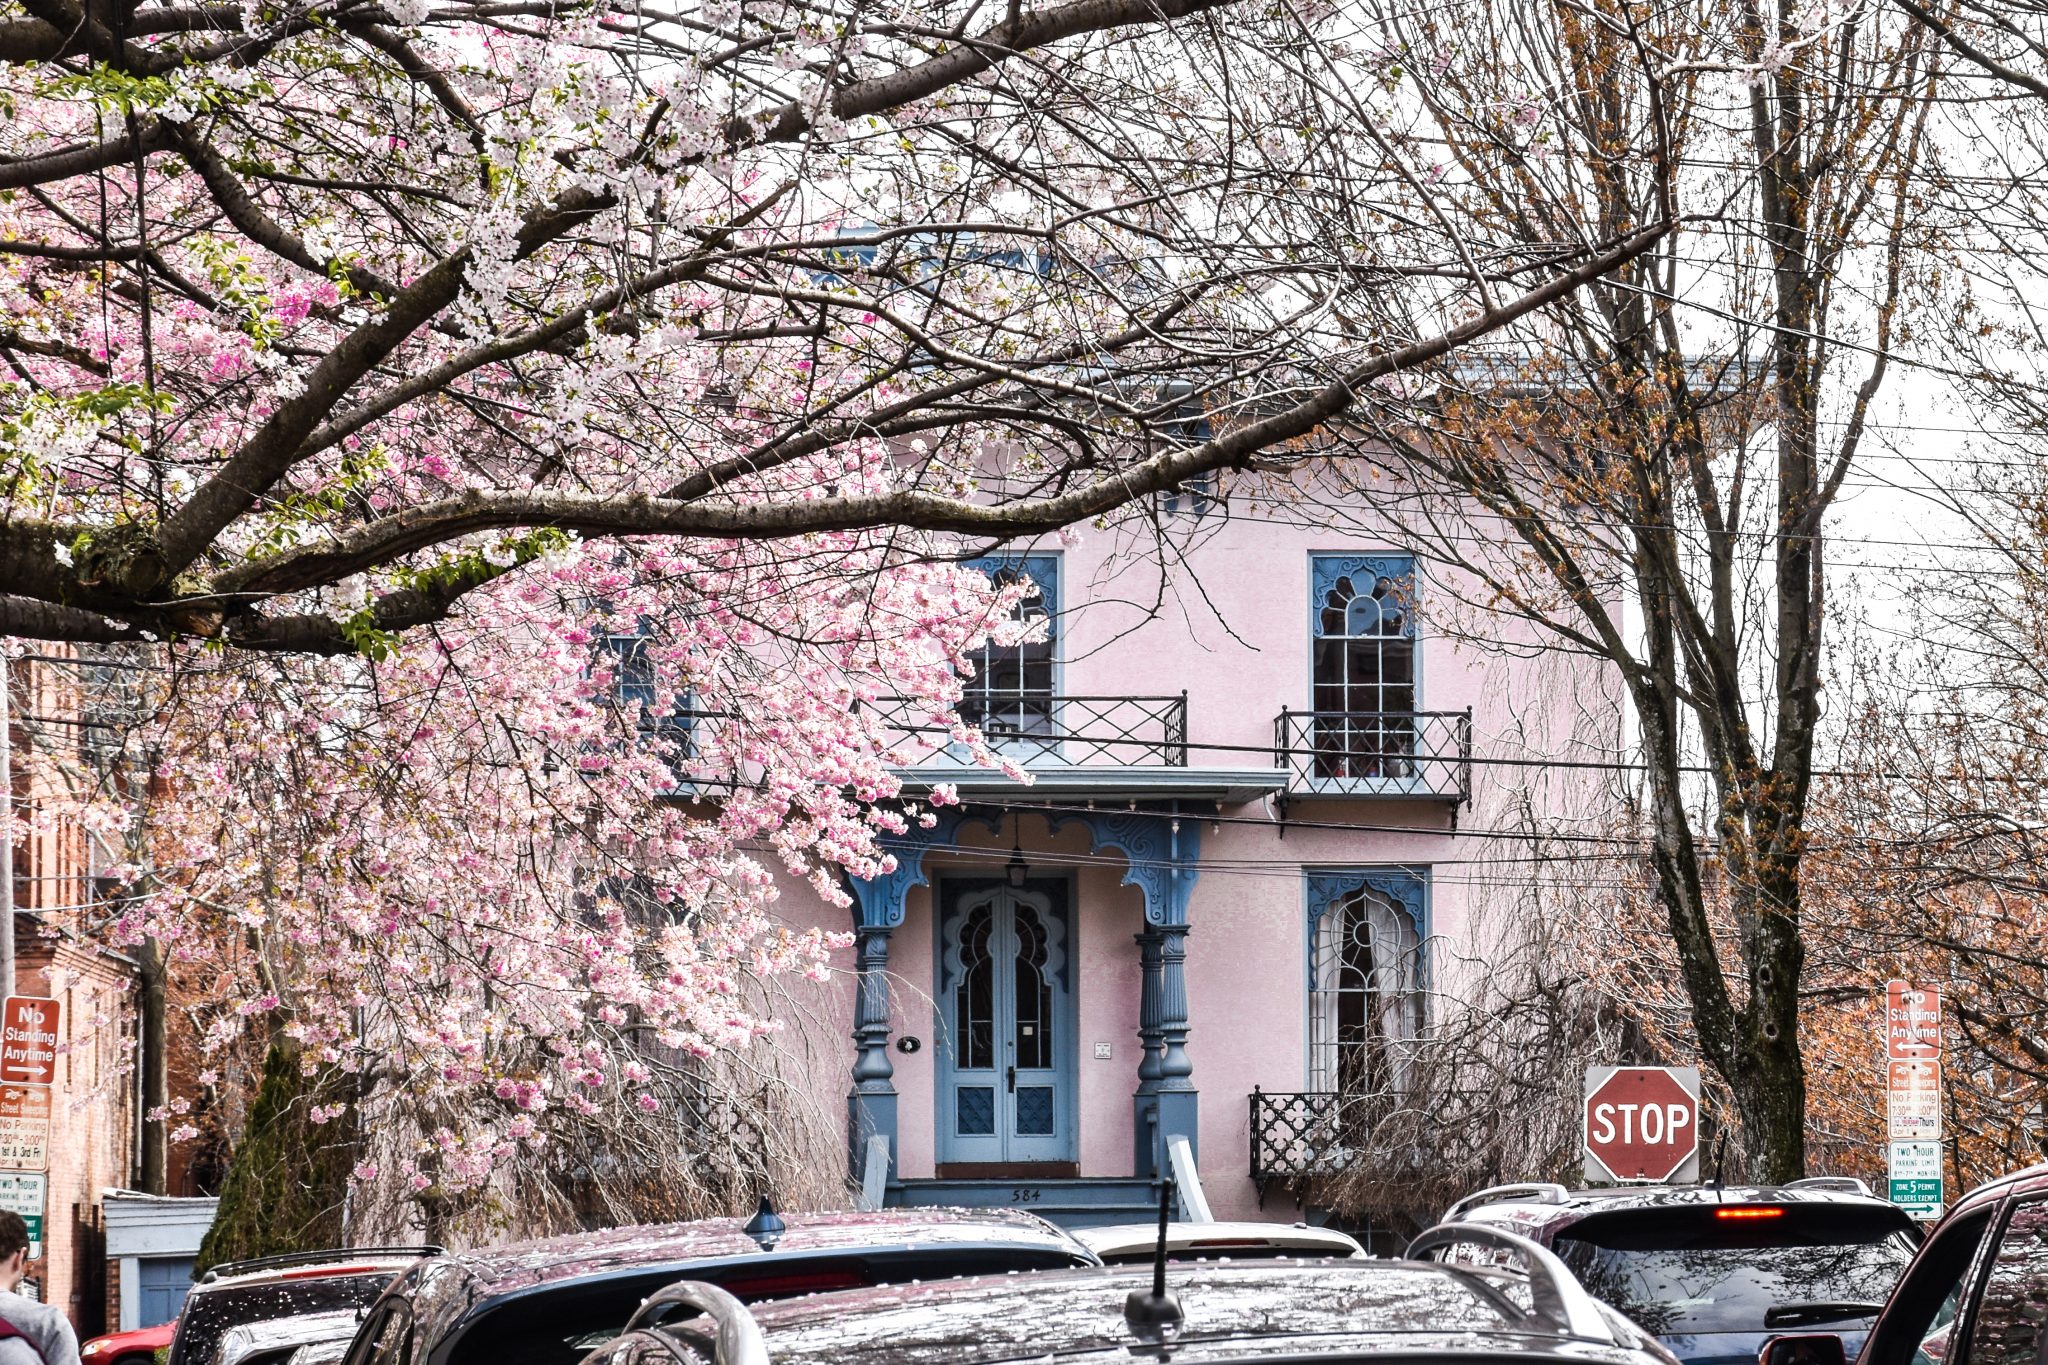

left=436, top=1209, right=1081, bottom=1295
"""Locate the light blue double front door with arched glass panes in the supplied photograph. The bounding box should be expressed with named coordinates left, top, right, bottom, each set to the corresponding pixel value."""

left=936, top=878, right=1075, bottom=1166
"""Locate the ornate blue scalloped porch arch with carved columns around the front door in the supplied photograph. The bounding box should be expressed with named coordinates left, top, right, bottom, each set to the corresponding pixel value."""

left=848, top=806, right=1202, bottom=1179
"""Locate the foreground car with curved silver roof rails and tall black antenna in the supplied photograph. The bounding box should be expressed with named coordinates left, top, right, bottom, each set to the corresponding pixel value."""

left=586, top=1230, right=1671, bottom=1365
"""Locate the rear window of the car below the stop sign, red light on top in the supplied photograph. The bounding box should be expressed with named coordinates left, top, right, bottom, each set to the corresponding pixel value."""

left=1554, top=1205, right=1915, bottom=1336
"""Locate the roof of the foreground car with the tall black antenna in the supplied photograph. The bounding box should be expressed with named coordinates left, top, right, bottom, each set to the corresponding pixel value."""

left=662, top=1259, right=1657, bottom=1365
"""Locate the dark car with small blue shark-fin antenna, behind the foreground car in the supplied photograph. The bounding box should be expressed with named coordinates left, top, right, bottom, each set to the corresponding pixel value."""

left=346, top=1205, right=1102, bottom=1365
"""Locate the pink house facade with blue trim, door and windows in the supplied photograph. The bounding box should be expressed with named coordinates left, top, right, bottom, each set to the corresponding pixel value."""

left=745, top=493, right=1618, bottom=1226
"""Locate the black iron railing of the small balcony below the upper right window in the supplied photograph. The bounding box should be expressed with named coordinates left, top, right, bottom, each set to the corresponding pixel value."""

left=1274, top=710, right=1473, bottom=804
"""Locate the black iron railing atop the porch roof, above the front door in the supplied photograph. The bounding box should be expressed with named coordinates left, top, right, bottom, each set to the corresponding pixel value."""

left=872, top=692, right=1188, bottom=767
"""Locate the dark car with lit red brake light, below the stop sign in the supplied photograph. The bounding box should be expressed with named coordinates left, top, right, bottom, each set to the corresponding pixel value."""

left=1444, top=1177, right=1919, bottom=1365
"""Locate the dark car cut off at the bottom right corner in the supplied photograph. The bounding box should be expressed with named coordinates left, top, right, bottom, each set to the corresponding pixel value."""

left=1761, top=1166, right=2048, bottom=1365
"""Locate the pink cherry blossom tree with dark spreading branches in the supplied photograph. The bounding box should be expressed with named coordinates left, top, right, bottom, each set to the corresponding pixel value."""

left=0, top=0, right=1669, bottom=1227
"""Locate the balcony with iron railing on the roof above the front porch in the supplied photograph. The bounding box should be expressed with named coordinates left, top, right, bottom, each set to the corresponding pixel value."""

left=870, top=692, right=1286, bottom=802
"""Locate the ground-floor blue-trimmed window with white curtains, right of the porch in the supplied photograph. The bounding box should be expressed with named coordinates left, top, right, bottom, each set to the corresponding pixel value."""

left=1307, top=868, right=1427, bottom=1095
